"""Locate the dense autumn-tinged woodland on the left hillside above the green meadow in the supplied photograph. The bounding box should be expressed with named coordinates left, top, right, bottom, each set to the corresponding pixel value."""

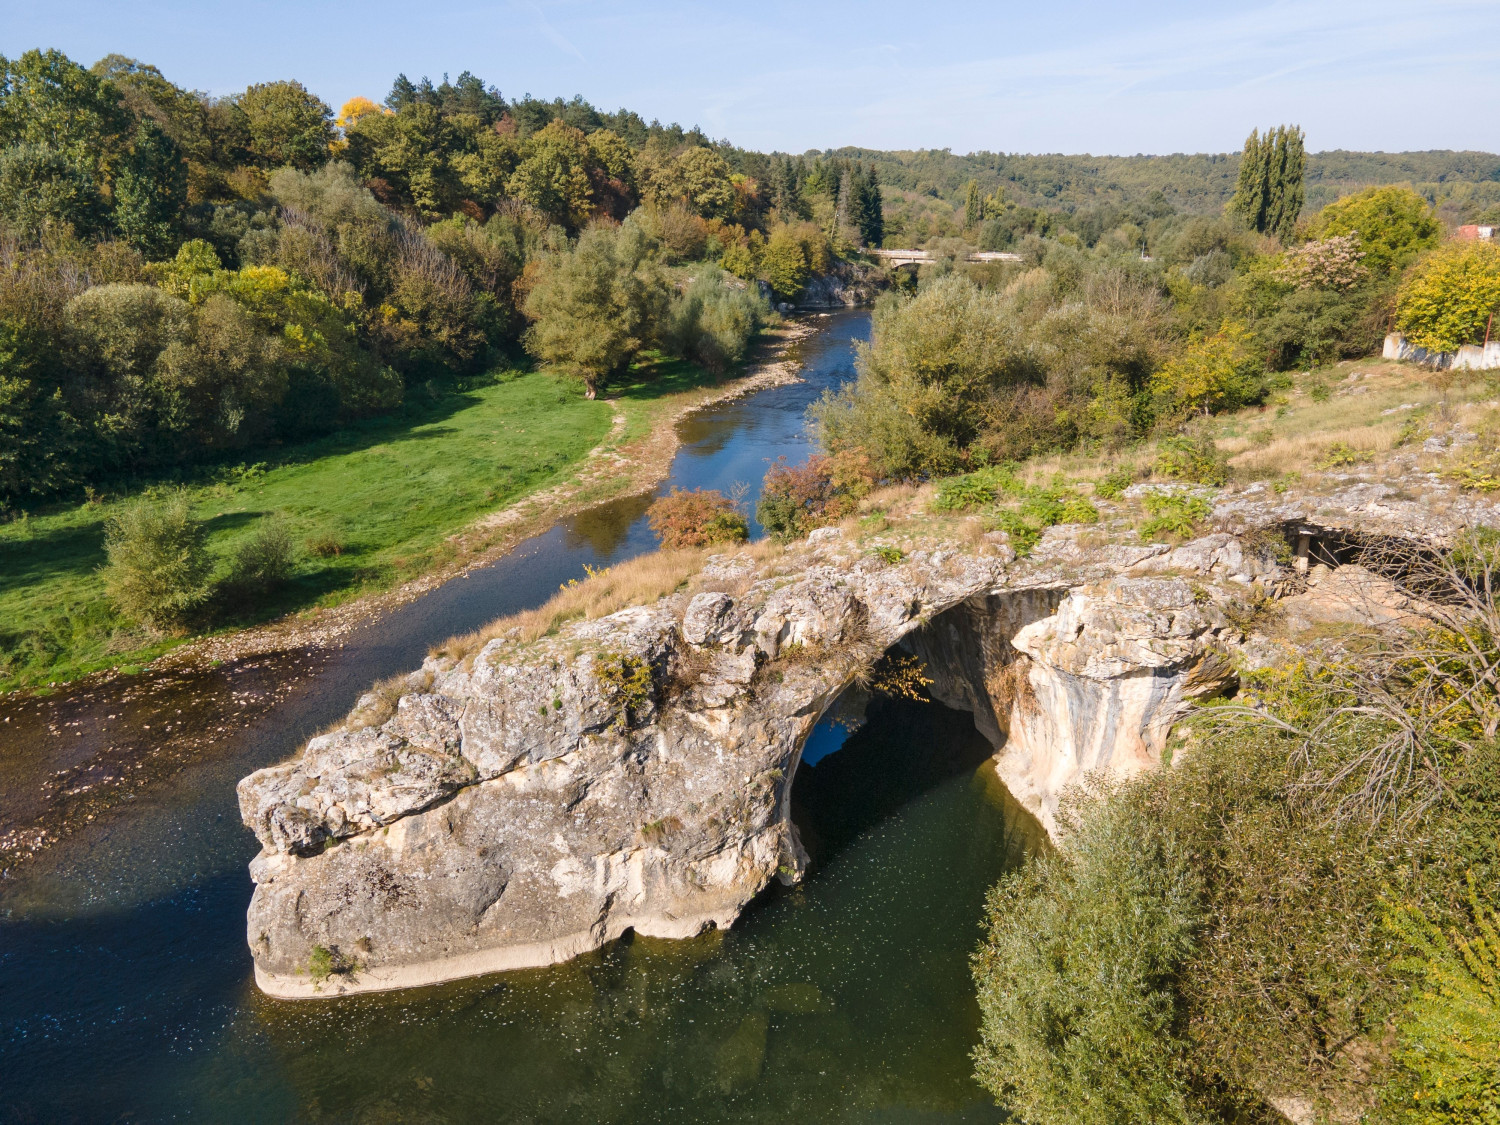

left=0, top=51, right=882, bottom=507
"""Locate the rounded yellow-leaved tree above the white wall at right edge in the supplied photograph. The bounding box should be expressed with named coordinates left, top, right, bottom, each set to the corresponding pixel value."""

left=1397, top=242, right=1500, bottom=351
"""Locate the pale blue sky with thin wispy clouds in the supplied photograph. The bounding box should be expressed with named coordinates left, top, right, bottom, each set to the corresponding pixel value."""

left=0, top=0, right=1500, bottom=155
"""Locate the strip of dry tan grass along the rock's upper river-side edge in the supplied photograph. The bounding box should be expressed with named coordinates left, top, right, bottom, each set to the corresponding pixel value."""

left=429, top=545, right=714, bottom=660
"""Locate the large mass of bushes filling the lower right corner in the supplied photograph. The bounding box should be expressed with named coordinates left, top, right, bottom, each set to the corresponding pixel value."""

left=975, top=543, right=1500, bottom=1125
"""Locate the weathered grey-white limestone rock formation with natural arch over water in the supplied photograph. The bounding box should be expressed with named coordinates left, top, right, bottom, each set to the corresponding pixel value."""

left=240, top=480, right=1476, bottom=996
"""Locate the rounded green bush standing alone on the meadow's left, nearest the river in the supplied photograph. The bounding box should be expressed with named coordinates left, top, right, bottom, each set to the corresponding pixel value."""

left=104, top=492, right=213, bottom=633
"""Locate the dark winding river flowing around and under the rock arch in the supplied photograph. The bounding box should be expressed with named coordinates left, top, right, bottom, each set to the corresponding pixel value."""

left=0, top=312, right=1037, bottom=1125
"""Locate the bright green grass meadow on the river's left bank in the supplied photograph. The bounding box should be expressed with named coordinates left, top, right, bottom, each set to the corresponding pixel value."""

left=0, top=365, right=624, bottom=690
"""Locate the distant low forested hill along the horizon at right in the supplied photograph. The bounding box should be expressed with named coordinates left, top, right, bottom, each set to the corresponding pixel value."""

left=810, top=149, right=1500, bottom=212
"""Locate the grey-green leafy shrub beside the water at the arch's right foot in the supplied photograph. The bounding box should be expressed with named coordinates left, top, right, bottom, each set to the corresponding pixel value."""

left=974, top=798, right=1208, bottom=1125
